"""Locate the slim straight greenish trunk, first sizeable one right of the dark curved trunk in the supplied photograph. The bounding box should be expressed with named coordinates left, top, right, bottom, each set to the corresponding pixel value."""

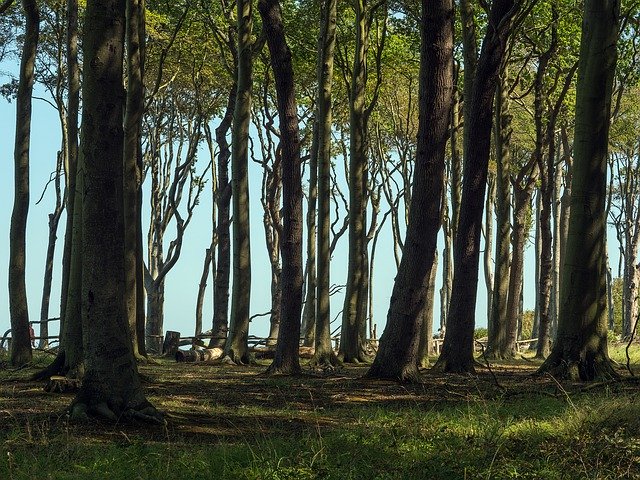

left=313, top=0, right=337, bottom=364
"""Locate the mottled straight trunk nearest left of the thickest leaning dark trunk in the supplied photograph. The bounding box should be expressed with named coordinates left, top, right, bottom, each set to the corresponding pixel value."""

left=338, top=0, right=369, bottom=363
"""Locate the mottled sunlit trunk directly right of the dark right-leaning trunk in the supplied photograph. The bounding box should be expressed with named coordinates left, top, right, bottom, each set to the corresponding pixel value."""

left=487, top=73, right=513, bottom=358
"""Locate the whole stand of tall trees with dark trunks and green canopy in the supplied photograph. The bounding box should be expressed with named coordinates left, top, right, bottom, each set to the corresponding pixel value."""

left=0, top=0, right=640, bottom=419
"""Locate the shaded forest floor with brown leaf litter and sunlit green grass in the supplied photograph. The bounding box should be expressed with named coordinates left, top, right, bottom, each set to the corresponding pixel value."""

left=0, top=348, right=640, bottom=480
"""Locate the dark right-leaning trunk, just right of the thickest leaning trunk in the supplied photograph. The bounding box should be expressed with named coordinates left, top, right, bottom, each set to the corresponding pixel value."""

left=436, top=0, right=519, bottom=372
